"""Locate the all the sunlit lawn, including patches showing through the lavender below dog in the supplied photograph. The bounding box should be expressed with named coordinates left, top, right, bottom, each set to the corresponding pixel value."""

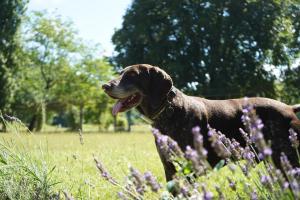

left=0, top=123, right=289, bottom=199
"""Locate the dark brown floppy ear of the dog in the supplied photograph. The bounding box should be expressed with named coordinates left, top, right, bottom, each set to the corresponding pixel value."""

left=148, top=67, right=173, bottom=109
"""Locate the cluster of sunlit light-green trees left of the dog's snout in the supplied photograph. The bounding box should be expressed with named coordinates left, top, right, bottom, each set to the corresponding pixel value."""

left=9, top=12, right=114, bottom=131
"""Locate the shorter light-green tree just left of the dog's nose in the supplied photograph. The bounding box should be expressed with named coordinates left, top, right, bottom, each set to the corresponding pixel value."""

left=55, top=49, right=113, bottom=130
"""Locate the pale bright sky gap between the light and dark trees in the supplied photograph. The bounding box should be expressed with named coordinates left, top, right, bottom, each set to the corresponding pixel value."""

left=28, top=0, right=132, bottom=56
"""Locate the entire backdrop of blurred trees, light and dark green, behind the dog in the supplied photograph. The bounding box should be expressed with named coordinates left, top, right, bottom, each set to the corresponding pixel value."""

left=0, top=0, right=300, bottom=131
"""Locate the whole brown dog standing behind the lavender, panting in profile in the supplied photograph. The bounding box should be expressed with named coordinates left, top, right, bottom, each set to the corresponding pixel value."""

left=102, top=64, right=300, bottom=180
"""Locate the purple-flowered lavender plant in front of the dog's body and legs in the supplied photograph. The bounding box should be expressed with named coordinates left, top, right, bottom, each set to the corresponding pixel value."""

left=95, top=99, right=300, bottom=200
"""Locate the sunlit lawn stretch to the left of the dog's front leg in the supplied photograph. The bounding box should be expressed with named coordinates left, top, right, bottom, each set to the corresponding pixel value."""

left=0, top=126, right=164, bottom=199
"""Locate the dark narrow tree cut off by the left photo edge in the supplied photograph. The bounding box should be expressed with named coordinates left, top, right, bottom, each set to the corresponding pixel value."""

left=0, top=0, right=27, bottom=126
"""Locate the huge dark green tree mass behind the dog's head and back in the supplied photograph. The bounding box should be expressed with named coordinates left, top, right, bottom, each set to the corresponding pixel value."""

left=112, top=0, right=299, bottom=98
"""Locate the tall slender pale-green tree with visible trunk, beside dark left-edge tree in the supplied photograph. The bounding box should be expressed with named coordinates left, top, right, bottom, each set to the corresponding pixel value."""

left=23, top=12, right=79, bottom=131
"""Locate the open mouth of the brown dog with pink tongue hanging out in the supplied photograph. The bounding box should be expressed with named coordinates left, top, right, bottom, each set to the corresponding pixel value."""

left=112, top=92, right=142, bottom=115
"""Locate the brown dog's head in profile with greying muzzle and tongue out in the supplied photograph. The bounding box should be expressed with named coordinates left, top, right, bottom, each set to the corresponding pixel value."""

left=102, top=64, right=173, bottom=115
